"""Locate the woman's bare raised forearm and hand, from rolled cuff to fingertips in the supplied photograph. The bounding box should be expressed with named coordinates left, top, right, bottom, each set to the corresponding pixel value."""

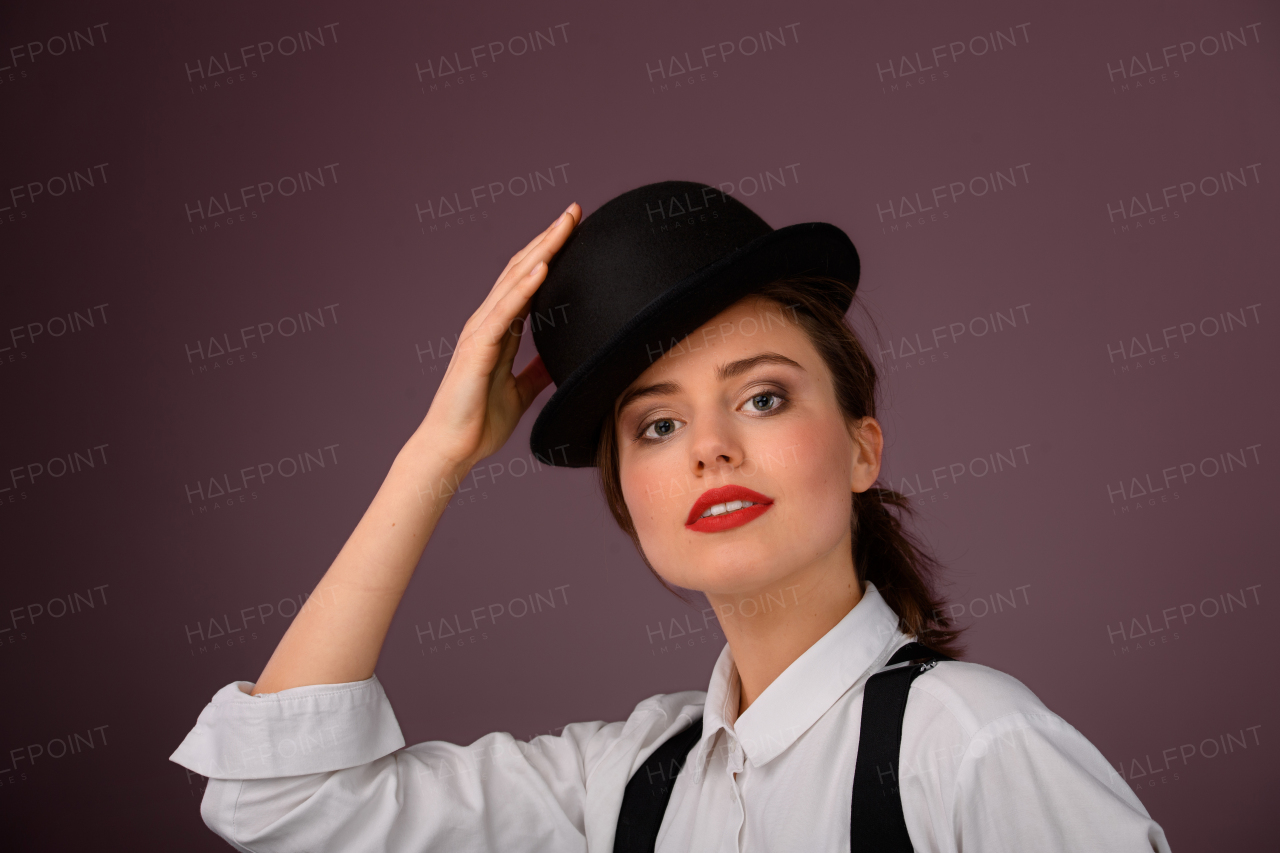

left=253, top=204, right=581, bottom=695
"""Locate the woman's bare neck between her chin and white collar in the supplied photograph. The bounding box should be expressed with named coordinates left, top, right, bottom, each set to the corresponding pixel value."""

left=707, top=547, right=863, bottom=715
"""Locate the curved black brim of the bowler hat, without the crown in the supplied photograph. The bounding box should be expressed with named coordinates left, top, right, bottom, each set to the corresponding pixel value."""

left=529, top=222, right=860, bottom=467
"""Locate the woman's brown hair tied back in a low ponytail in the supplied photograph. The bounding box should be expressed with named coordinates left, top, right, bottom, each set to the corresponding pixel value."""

left=596, top=277, right=961, bottom=657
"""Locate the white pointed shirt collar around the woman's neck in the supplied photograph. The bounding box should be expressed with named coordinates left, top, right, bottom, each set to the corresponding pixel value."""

left=691, top=581, right=906, bottom=772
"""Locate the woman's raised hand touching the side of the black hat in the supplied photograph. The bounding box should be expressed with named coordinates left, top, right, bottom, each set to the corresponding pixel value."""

left=419, top=202, right=582, bottom=470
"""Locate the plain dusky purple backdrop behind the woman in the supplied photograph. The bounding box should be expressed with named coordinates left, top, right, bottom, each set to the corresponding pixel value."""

left=0, top=0, right=1280, bottom=850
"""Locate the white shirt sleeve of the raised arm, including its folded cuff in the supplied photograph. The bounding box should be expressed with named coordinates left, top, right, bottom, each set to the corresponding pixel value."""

left=170, top=676, right=623, bottom=853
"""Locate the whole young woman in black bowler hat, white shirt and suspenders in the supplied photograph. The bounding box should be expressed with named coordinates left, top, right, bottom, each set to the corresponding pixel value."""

left=173, top=182, right=1167, bottom=853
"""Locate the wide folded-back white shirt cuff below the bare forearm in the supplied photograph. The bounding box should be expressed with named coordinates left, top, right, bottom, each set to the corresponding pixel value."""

left=169, top=675, right=404, bottom=779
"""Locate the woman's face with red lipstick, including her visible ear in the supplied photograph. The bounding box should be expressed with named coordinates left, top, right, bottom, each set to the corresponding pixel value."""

left=616, top=297, right=881, bottom=596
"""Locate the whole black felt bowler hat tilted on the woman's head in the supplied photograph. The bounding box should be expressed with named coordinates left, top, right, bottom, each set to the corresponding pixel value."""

left=529, top=181, right=859, bottom=467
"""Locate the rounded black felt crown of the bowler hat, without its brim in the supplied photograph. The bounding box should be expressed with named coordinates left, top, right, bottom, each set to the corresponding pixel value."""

left=529, top=181, right=773, bottom=384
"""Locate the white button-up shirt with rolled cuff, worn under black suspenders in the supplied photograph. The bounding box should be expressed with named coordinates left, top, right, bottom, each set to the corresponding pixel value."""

left=170, top=584, right=1169, bottom=853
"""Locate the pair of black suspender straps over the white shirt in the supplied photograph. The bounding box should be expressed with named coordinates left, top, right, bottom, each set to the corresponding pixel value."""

left=613, top=643, right=951, bottom=853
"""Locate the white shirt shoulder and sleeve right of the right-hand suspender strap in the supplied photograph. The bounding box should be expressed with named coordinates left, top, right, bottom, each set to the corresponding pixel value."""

left=900, top=662, right=1169, bottom=853
